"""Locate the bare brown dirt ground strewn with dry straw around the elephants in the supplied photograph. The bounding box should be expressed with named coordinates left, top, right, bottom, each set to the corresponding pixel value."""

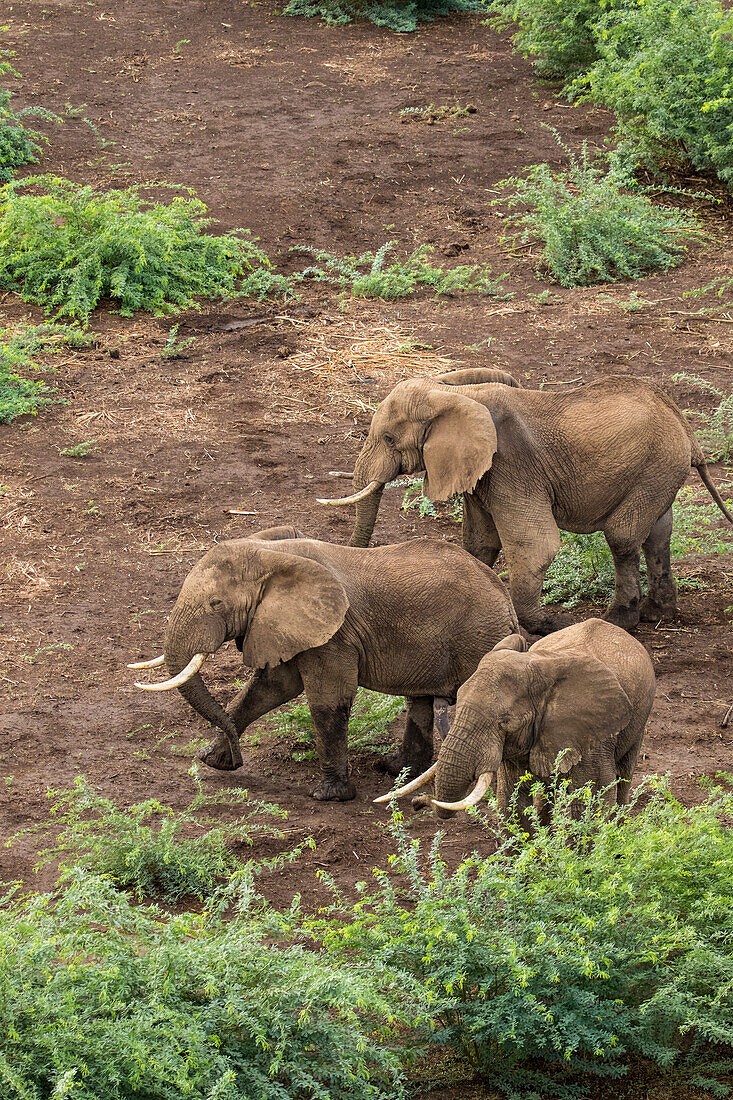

left=0, top=0, right=733, bottom=1096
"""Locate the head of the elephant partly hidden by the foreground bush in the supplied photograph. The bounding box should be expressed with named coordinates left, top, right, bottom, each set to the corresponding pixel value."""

left=434, top=635, right=632, bottom=816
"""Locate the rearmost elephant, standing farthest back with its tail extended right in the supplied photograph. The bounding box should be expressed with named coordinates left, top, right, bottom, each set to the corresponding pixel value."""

left=319, top=370, right=733, bottom=635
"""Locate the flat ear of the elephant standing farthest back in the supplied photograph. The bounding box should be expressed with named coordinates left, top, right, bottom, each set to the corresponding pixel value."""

left=423, top=391, right=496, bottom=501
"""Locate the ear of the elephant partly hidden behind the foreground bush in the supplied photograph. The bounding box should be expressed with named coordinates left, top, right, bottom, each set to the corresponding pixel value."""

left=529, top=656, right=632, bottom=776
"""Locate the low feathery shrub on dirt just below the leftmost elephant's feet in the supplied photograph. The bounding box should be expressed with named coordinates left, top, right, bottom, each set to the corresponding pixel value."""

left=10, top=766, right=287, bottom=901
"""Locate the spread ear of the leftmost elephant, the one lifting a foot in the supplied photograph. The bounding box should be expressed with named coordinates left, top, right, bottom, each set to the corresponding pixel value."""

left=236, top=548, right=349, bottom=669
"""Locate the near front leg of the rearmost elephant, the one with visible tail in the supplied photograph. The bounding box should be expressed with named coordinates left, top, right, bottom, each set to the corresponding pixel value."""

left=500, top=512, right=575, bottom=634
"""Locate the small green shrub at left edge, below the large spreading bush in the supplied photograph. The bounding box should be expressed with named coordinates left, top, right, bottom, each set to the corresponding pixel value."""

left=0, top=325, right=94, bottom=424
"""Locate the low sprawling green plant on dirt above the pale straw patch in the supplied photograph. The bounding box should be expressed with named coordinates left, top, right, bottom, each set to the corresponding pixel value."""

left=291, top=241, right=511, bottom=300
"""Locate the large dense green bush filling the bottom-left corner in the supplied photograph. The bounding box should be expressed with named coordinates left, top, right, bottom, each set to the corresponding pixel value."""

left=0, top=866, right=404, bottom=1100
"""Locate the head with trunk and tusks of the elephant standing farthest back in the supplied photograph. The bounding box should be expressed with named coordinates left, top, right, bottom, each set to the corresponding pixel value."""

left=320, top=372, right=499, bottom=547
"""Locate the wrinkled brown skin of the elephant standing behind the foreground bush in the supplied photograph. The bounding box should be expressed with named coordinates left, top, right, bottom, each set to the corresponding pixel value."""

left=435, top=618, right=655, bottom=816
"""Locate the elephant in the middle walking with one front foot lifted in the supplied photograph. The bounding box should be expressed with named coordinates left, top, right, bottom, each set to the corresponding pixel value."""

left=129, top=527, right=519, bottom=801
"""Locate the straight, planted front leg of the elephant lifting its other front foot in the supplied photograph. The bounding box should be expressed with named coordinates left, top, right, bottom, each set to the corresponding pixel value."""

left=296, top=652, right=359, bottom=802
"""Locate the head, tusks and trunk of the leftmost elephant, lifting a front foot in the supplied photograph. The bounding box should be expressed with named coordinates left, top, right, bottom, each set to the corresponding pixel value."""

left=130, top=531, right=349, bottom=766
